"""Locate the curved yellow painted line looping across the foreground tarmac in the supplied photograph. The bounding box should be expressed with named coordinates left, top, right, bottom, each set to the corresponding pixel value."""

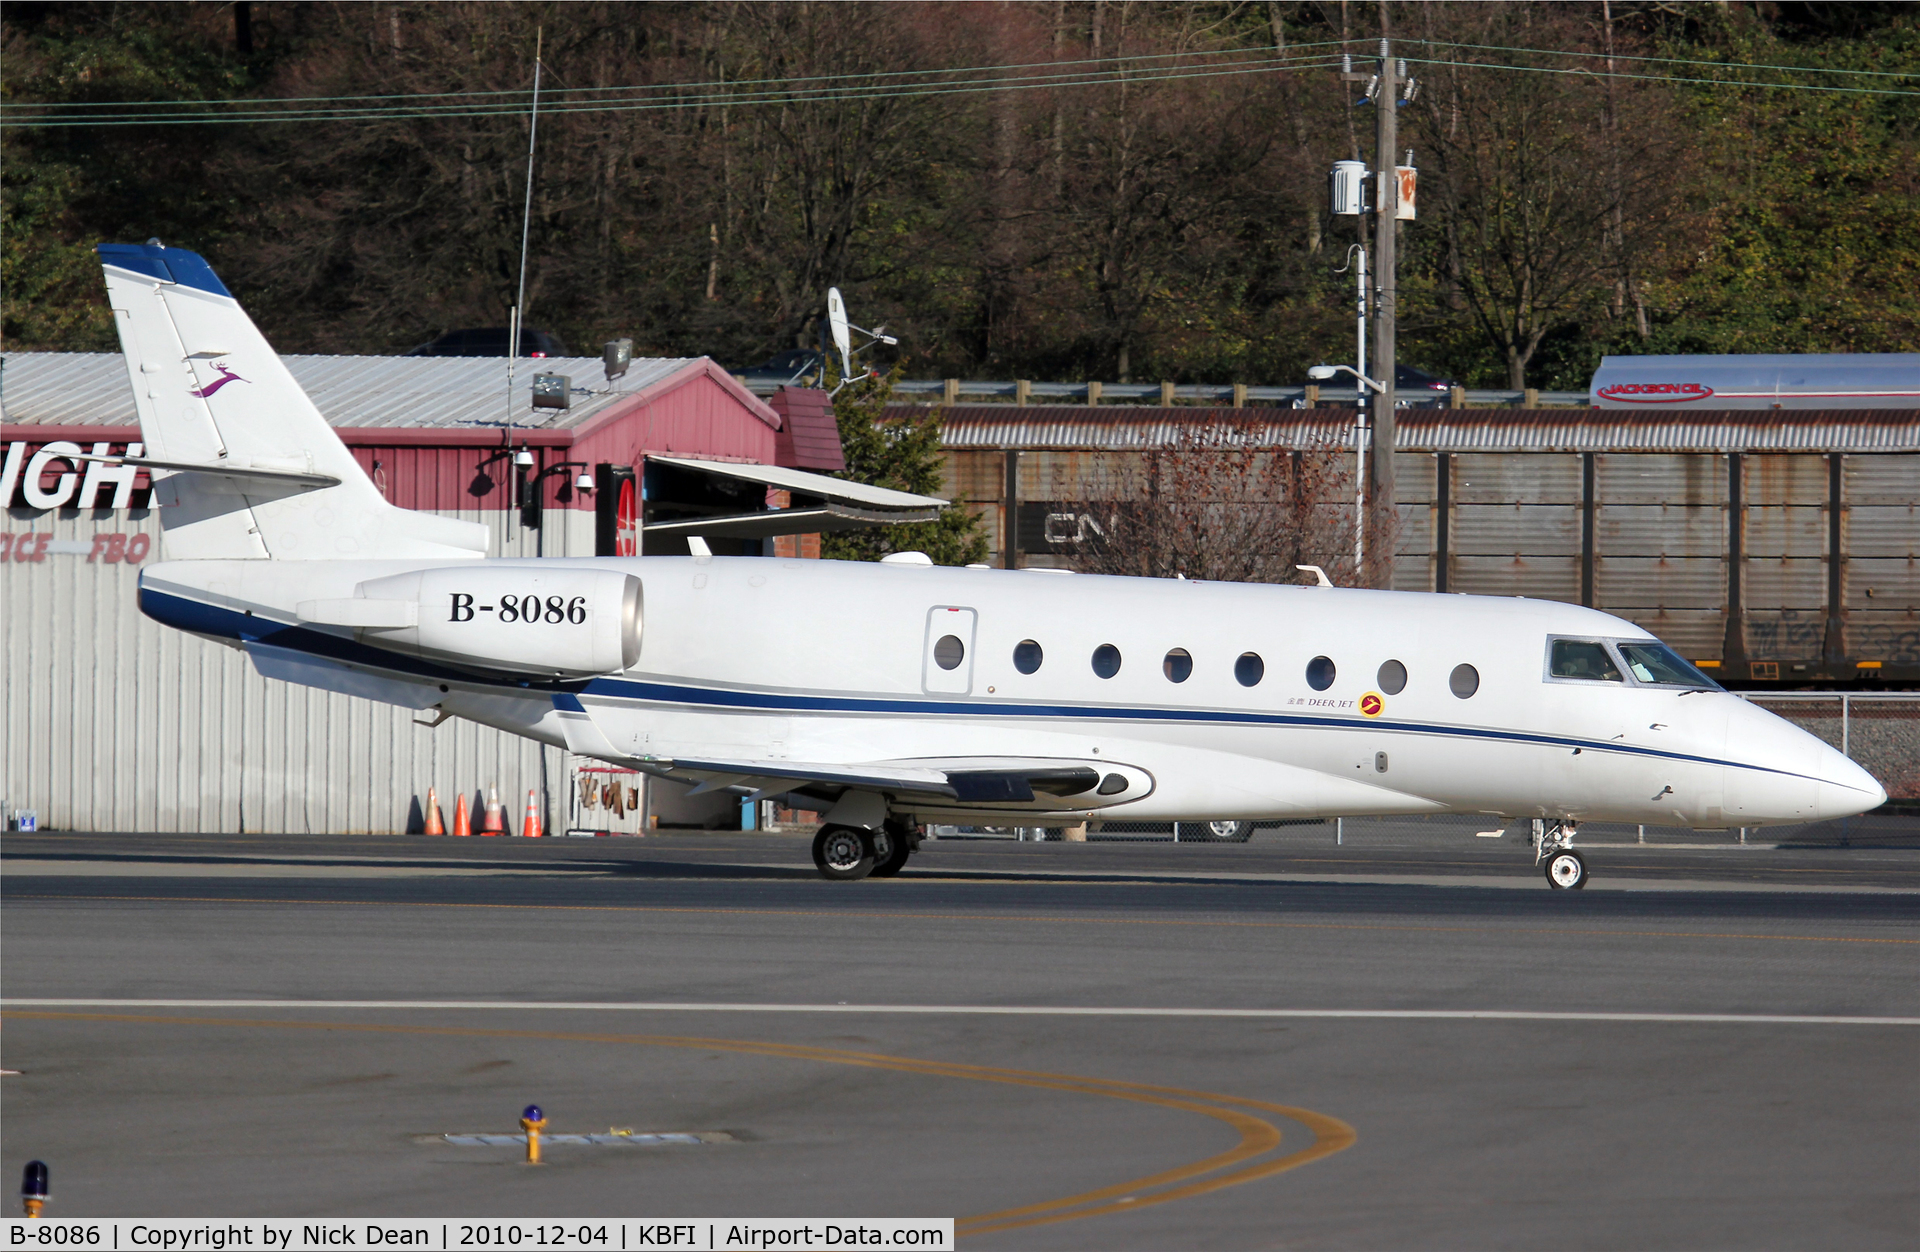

left=6, top=1010, right=1359, bottom=1235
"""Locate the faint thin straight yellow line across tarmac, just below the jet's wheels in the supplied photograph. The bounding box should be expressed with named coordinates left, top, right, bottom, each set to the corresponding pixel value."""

left=13, top=893, right=1920, bottom=947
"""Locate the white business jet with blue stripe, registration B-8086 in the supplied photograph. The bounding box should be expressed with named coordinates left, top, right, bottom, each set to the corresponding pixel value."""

left=100, top=244, right=1885, bottom=887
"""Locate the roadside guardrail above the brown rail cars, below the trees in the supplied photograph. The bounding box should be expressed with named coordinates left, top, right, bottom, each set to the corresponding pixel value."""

left=747, top=378, right=1588, bottom=409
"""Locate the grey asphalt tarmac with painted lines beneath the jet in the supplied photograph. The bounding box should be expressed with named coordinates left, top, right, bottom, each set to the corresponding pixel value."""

left=0, top=831, right=1920, bottom=1248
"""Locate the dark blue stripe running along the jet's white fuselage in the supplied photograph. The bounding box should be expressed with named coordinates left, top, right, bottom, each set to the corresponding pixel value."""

left=140, top=582, right=1818, bottom=782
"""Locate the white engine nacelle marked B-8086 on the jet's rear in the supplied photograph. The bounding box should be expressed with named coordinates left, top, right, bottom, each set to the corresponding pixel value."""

left=344, top=563, right=641, bottom=678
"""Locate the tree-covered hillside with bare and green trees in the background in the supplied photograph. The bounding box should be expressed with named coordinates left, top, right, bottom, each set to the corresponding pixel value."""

left=0, top=0, right=1920, bottom=388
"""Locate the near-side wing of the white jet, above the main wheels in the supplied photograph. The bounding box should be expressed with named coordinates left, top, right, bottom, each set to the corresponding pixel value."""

left=659, top=757, right=1121, bottom=805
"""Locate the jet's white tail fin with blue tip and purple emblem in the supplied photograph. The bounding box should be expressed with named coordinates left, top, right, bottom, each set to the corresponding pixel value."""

left=98, top=244, right=488, bottom=561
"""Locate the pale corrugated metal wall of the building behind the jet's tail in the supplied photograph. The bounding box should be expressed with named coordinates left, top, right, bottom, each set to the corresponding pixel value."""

left=0, top=509, right=576, bottom=831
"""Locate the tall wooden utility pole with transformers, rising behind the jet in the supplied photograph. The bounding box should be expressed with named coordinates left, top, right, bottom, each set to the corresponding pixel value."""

left=1359, top=38, right=1402, bottom=588
